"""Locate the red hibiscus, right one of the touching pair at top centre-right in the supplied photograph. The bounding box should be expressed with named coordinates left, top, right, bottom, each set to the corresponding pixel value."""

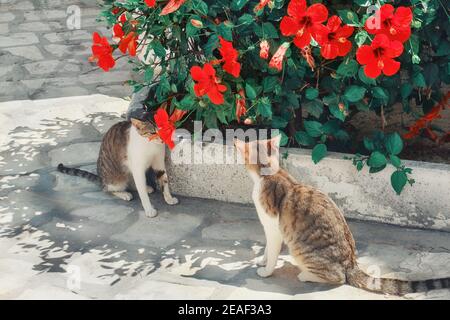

left=315, top=16, right=353, bottom=59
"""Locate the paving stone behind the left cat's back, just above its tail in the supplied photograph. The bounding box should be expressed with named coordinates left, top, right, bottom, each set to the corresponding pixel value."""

left=49, top=142, right=100, bottom=167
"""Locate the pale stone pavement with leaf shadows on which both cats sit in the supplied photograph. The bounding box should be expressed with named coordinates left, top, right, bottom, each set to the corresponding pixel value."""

left=0, top=95, right=450, bottom=299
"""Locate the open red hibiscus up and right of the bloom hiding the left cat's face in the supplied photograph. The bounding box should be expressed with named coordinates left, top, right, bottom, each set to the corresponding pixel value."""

left=191, top=63, right=227, bottom=104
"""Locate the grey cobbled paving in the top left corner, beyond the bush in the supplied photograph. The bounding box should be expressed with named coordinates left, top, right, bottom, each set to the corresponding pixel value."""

left=0, top=0, right=131, bottom=101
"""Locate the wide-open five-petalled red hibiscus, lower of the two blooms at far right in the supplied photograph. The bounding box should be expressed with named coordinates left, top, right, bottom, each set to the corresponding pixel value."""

left=356, top=34, right=403, bottom=78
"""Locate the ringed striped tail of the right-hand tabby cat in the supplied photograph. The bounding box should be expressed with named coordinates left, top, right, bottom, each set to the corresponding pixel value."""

left=347, top=266, right=450, bottom=296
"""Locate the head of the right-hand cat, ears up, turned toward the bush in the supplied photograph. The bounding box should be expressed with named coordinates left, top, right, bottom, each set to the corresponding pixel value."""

left=234, top=135, right=281, bottom=175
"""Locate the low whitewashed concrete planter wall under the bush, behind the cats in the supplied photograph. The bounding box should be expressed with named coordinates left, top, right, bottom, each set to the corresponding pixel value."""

left=167, top=143, right=450, bottom=231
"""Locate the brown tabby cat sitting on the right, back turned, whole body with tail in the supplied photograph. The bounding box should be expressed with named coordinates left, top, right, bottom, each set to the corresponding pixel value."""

left=235, top=136, right=450, bottom=295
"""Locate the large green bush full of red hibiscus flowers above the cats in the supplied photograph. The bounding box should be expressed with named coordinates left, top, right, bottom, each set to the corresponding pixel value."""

left=92, top=0, right=450, bottom=194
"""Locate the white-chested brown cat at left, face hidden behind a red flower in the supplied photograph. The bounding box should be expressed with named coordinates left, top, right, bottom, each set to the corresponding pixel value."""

left=58, top=119, right=178, bottom=217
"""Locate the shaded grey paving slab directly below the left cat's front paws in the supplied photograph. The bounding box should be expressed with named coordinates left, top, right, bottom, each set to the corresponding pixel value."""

left=112, top=211, right=202, bottom=248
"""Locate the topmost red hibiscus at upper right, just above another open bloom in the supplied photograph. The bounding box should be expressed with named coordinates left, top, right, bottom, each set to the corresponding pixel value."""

left=365, top=4, right=413, bottom=43
